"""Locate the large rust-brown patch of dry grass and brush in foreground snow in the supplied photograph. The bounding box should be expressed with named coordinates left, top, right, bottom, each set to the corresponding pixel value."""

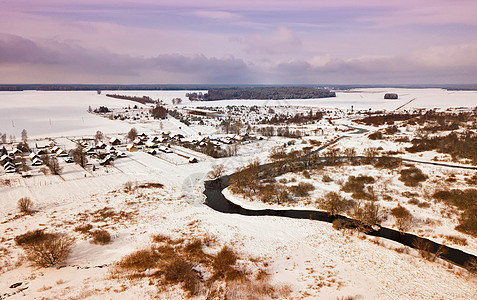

left=114, top=235, right=283, bottom=299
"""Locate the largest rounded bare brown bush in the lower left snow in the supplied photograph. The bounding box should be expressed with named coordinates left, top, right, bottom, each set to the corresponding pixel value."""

left=22, top=234, right=74, bottom=267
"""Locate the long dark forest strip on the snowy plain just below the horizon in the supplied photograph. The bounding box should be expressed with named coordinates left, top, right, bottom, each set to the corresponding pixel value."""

left=186, top=87, right=336, bottom=101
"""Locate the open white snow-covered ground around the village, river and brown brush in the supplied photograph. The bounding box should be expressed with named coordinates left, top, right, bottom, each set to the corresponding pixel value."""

left=0, top=89, right=477, bottom=299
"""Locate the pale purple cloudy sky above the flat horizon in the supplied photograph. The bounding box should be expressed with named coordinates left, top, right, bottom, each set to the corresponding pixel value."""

left=0, top=0, right=477, bottom=84
